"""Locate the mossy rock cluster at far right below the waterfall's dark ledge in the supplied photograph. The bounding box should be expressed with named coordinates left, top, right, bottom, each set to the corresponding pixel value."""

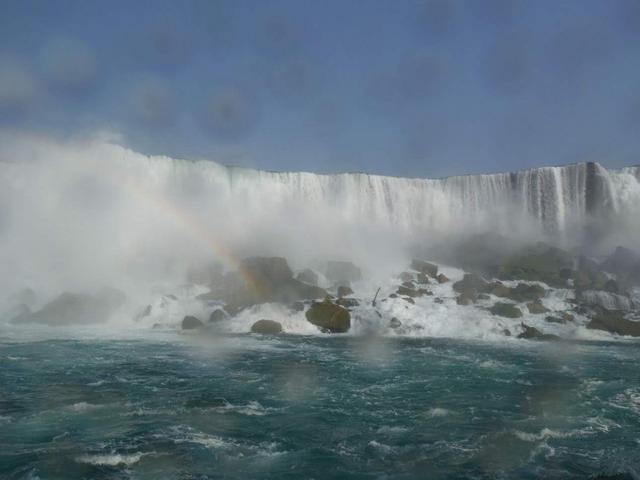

left=453, top=243, right=640, bottom=340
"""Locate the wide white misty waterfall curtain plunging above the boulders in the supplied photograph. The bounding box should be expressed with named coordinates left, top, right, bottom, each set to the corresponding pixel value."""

left=0, top=134, right=640, bottom=288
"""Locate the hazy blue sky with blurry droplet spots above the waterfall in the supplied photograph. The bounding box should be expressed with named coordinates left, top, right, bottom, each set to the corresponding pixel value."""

left=0, top=0, right=640, bottom=176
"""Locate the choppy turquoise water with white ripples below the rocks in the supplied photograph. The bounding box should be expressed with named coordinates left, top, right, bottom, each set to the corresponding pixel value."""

left=0, top=335, right=640, bottom=479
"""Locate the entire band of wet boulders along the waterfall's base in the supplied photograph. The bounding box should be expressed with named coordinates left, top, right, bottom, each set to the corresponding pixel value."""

left=6, top=243, right=640, bottom=340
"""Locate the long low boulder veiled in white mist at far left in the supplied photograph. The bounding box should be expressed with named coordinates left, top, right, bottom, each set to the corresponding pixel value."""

left=12, top=288, right=126, bottom=326
